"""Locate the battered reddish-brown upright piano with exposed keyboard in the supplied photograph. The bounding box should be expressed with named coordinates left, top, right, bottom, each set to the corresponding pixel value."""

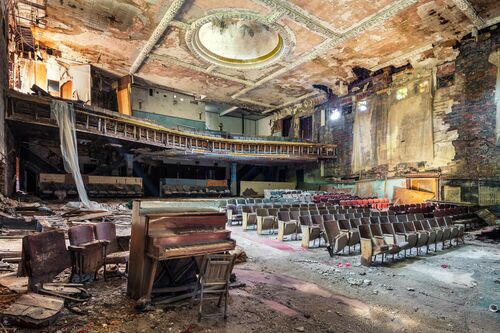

left=127, top=200, right=236, bottom=302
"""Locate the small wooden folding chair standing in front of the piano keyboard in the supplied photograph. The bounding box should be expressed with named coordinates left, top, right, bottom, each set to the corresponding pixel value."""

left=193, top=254, right=236, bottom=321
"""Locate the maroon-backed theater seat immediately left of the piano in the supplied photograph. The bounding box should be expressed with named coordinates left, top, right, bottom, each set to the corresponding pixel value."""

left=94, top=222, right=130, bottom=281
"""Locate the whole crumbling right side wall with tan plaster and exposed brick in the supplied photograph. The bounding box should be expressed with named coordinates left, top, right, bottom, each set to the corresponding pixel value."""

left=319, top=27, right=500, bottom=179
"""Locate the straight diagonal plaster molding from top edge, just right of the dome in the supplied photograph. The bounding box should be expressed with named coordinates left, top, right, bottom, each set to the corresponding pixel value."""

left=254, top=0, right=341, bottom=38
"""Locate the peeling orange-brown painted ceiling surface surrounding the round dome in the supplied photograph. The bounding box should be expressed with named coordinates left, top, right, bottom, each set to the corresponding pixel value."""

left=17, top=0, right=500, bottom=110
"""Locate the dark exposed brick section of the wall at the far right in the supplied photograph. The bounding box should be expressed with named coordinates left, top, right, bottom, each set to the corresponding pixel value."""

left=443, top=29, right=500, bottom=178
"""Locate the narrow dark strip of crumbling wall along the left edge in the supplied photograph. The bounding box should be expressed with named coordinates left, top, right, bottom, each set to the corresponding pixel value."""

left=0, top=0, right=9, bottom=193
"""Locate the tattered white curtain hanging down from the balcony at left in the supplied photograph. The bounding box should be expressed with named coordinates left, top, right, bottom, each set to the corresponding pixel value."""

left=50, top=100, right=91, bottom=208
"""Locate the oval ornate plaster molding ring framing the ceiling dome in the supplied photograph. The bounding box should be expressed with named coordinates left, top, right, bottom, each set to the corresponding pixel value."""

left=185, top=9, right=295, bottom=70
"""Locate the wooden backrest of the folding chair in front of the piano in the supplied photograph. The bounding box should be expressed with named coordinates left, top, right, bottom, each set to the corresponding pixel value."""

left=200, top=254, right=236, bottom=285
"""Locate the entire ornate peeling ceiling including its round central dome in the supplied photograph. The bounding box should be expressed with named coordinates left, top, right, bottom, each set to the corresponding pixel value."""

left=25, top=0, right=500, bottom=112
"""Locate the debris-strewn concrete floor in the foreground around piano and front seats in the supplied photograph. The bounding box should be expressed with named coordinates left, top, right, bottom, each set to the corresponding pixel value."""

left=0, top=214, right=500, bottom=333
